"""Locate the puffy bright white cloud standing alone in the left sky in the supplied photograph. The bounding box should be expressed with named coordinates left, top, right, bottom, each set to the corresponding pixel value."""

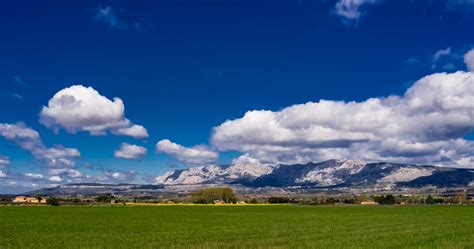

left=40, top=85, right=148, bottom=138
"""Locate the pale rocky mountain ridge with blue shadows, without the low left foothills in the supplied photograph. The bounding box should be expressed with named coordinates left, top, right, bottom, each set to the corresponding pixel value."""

left=156, top=160, right=474, bottom=189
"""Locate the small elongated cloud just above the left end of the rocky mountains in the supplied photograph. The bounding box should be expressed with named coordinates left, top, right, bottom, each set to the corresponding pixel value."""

left=156, top=139, right=219, bottom=165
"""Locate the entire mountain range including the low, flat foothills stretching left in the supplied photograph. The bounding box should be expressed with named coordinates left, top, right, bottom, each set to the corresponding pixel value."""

left=25, top=160, right=474, bottom=196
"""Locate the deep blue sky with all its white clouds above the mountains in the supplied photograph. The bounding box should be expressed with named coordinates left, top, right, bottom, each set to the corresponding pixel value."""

left=0, top=0, right=474, bottom=193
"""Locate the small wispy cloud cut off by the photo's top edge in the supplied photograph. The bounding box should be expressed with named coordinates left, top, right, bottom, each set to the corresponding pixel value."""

left=334, top=0, right=380, bottom=24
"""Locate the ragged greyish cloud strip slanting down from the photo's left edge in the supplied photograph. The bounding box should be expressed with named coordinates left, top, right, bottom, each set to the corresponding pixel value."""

left=0, top=123, right=80, bottom=168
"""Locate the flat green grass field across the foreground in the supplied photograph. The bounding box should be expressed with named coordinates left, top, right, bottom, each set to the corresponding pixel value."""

left=0, top=205, right=474, bottom=248
